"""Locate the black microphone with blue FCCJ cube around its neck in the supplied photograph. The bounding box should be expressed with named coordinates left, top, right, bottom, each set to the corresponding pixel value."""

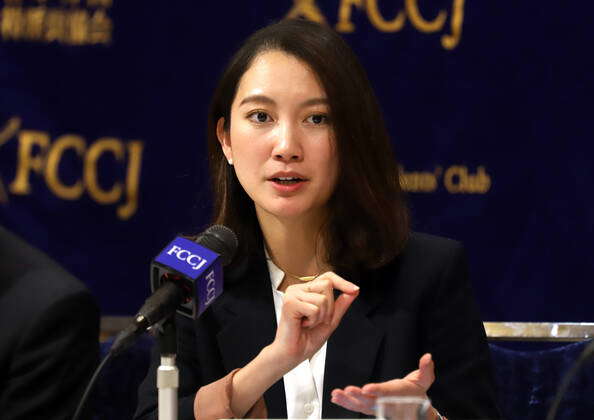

left=110, top=225, right=237, bottom=355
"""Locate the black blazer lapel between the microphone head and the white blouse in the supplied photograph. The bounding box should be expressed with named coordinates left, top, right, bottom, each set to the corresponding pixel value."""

left=217, top=254, right=287, bottom=418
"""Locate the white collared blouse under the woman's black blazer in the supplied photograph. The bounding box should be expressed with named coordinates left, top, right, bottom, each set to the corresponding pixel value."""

left=267, top=259, right=328, bottom=419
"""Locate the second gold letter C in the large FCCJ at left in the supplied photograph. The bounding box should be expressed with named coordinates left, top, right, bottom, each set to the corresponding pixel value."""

left=83, top=137, right=124, bottom=204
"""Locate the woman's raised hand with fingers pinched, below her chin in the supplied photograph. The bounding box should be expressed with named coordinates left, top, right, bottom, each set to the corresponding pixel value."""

left=269, top=272, right=359, bottom=370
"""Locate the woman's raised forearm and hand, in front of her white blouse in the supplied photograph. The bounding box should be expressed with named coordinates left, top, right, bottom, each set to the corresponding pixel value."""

left=194, top=272, right=359, bottom=417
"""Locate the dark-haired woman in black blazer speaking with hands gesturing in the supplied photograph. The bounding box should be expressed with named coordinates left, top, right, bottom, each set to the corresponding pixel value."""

left=136, top=20, right=500, bottom=420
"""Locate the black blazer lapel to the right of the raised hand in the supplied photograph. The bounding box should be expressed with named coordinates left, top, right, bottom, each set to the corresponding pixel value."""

left=322, top=270, right=382, bottom=418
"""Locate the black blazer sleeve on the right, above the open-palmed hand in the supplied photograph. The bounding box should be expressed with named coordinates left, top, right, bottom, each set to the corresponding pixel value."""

left=421, top=241, right=501, bottom=420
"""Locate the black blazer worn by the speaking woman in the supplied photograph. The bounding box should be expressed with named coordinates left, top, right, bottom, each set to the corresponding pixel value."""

left=136, top=234, right=500, bottom=419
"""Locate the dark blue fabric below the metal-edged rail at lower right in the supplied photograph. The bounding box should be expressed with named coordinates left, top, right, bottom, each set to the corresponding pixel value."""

left=490, top=341, right=594, bottom=420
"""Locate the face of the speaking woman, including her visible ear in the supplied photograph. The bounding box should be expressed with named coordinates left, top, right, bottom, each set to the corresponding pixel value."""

left=217, top=51, right=338, bottom=223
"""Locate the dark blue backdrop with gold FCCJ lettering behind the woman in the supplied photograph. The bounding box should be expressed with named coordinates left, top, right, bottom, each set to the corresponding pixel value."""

left=0, top=0, right=594, bottom=321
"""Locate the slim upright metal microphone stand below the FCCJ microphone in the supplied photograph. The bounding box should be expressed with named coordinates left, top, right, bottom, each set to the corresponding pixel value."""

left=157, top=315, right=179, bottom=420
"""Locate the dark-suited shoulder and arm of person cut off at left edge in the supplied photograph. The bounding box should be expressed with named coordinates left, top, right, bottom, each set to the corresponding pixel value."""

left=0, top=227, right=99, bottom=420
